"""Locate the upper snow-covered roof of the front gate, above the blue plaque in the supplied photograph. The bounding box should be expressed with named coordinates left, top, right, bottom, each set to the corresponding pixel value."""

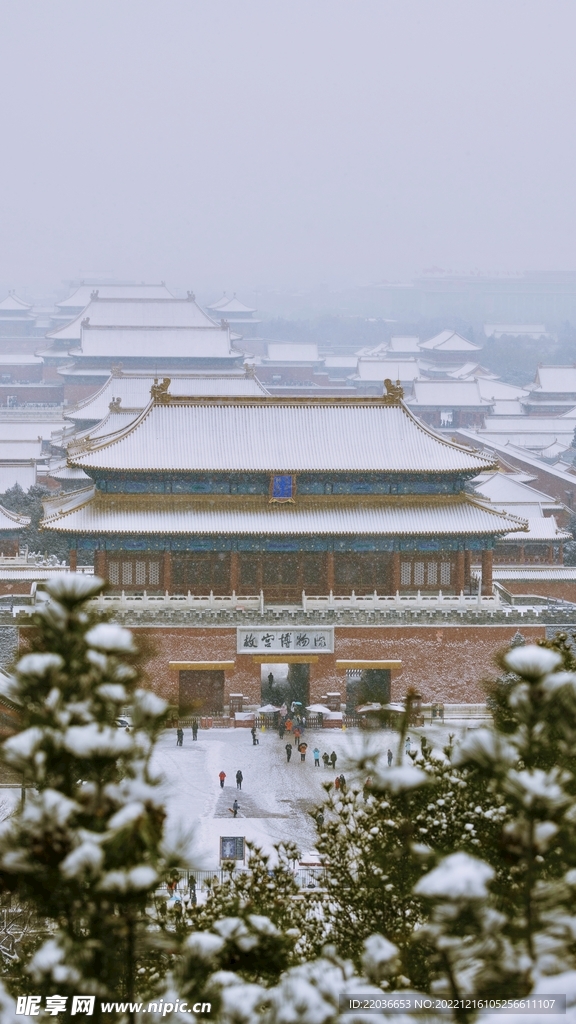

left=70, top=391, right=491, bottom=473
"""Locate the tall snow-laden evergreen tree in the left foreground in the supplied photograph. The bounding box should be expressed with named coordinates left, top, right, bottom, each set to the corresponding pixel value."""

left=0, top=574, right=166, bottom=1006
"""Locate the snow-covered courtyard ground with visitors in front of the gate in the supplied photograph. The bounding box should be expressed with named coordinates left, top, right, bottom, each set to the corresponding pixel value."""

left=153, top=725, right=460, bottom=869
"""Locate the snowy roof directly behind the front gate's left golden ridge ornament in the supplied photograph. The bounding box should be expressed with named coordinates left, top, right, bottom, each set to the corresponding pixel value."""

left=67, top=374, right=269, bottom=423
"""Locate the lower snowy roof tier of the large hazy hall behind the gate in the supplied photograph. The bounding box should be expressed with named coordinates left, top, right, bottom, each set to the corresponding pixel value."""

left=71, top=325, right=233, bottom=359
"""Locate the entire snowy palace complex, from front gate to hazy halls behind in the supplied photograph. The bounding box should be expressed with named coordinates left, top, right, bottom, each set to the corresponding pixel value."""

left=0, top=283, right=576, bottom=715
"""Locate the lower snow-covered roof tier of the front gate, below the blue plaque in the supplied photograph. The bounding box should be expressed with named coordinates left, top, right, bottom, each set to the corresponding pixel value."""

left=42, top=488, right=526, bottom=537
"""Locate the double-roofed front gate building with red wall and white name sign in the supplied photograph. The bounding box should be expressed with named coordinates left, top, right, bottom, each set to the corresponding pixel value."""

left=38, top=379, right=526, bottom=712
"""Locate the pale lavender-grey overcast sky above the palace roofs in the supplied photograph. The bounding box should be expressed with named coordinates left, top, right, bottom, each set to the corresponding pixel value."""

left=0, top=0, right=576, bottom=297
